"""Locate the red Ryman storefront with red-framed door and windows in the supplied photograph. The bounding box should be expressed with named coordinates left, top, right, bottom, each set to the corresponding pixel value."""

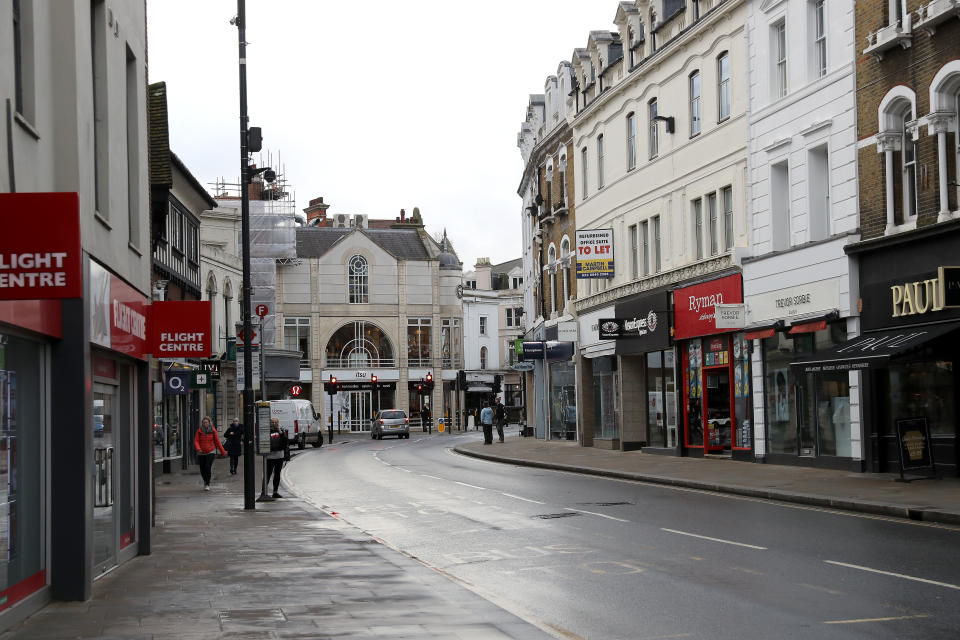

left=673, top=273, right=753, bottom=460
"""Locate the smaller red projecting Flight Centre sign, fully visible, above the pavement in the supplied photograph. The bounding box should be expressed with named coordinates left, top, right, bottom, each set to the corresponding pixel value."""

left=150, top=300, right=212, bottom=358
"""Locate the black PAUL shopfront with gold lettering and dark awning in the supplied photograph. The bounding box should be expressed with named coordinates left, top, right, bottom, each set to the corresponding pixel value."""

left=836, top=221, right=960, bottom=477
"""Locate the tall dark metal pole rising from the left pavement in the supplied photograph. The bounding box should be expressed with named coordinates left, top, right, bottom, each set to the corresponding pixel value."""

left=236, top=0, right=257, bottom=509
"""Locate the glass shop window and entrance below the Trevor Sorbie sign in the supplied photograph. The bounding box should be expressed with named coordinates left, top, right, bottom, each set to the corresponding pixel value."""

left=763, top=321, right=852, bottom=457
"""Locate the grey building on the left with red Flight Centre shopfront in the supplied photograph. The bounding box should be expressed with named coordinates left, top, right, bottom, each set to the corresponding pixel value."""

left=0, top=0, right=152, bottom=628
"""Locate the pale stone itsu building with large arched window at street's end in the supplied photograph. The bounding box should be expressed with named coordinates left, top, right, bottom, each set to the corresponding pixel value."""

left=273, top=204, right=464, bottom=431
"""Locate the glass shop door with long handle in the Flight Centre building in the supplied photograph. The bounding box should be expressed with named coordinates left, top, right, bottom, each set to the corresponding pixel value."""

left=93, top=383, right=117, bottom=575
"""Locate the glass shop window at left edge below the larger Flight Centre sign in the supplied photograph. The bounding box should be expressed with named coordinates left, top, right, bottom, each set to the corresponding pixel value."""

left=0, top=335, right=47, bottom=611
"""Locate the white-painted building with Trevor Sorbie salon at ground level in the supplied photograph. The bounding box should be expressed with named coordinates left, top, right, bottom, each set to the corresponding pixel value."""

left=743, top=0, right=863, bottom=471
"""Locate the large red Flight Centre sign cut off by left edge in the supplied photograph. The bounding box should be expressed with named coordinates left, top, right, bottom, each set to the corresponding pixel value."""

left=0, top=193, right=83, bottom=300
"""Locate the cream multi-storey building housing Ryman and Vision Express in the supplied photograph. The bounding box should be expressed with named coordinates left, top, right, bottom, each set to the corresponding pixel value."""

left=571, top=0, right=754, bottom=459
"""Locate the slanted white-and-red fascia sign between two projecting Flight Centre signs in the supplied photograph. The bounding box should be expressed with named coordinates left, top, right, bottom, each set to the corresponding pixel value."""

left=90, top=260, right=150, bottom=360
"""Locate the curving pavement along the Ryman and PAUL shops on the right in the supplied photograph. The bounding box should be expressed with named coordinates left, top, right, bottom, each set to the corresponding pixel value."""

left=454, top=427, right=960, bottom=525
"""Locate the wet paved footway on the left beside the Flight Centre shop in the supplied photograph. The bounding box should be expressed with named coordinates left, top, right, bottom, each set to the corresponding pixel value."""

left=0, top=442, right=553, bottom=640
